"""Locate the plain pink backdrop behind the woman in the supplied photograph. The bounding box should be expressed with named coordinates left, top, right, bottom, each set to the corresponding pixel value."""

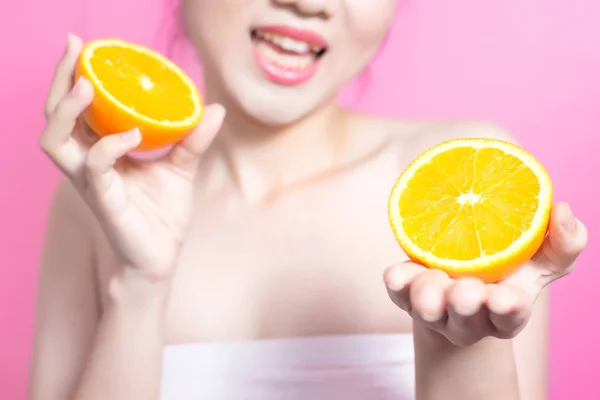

left=0, top=0, right=600, bottom=400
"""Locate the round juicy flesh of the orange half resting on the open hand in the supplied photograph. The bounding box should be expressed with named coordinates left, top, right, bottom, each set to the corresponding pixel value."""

left=400, top=147, right=540, bottom=260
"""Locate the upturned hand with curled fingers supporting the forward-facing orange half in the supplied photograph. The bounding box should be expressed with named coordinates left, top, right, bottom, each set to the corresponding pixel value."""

left=385, top=204, right=587, bottom=345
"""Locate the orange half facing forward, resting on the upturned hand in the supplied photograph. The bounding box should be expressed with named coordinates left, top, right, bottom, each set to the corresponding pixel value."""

left=388, top=138, right=552, bottom=283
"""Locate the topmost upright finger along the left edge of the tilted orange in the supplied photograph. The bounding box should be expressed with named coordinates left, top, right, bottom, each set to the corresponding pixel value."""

left=44, top=34, right=83, bottom=118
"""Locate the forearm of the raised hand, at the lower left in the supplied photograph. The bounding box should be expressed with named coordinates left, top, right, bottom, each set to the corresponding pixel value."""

left=73, top=277, right=168, bottom=400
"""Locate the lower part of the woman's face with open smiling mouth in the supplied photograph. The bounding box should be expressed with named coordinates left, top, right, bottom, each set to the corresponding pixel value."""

left=182, top=0, right=397, bottom=126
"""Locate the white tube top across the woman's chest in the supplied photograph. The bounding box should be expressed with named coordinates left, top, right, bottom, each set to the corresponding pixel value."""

left=161, top=334, right=415, bottom=400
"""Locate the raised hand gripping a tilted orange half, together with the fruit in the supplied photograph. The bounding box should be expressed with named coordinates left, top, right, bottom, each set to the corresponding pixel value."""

left=39, top=35, right=225, bottom=278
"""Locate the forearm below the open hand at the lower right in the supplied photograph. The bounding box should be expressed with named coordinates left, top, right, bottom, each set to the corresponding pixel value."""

left=413, top=323, right=519, bottom=400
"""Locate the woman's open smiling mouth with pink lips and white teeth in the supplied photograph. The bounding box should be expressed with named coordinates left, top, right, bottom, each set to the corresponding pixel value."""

left=251, top=27, right=327, bottom=84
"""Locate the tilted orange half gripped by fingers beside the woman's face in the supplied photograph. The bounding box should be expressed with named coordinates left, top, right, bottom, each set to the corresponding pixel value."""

left=75, top=39, right=204, bottom=150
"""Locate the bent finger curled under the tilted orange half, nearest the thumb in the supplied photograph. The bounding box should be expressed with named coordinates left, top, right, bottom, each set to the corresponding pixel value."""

left=85, top=129, right=142, bottom=194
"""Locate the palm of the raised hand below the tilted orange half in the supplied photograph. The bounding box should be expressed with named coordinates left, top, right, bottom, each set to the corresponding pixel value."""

left=90, top=159, right=194, bottom=274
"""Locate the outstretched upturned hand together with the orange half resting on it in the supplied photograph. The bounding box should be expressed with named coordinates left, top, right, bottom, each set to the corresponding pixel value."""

left=384, top=139, right=587, bottom=346
